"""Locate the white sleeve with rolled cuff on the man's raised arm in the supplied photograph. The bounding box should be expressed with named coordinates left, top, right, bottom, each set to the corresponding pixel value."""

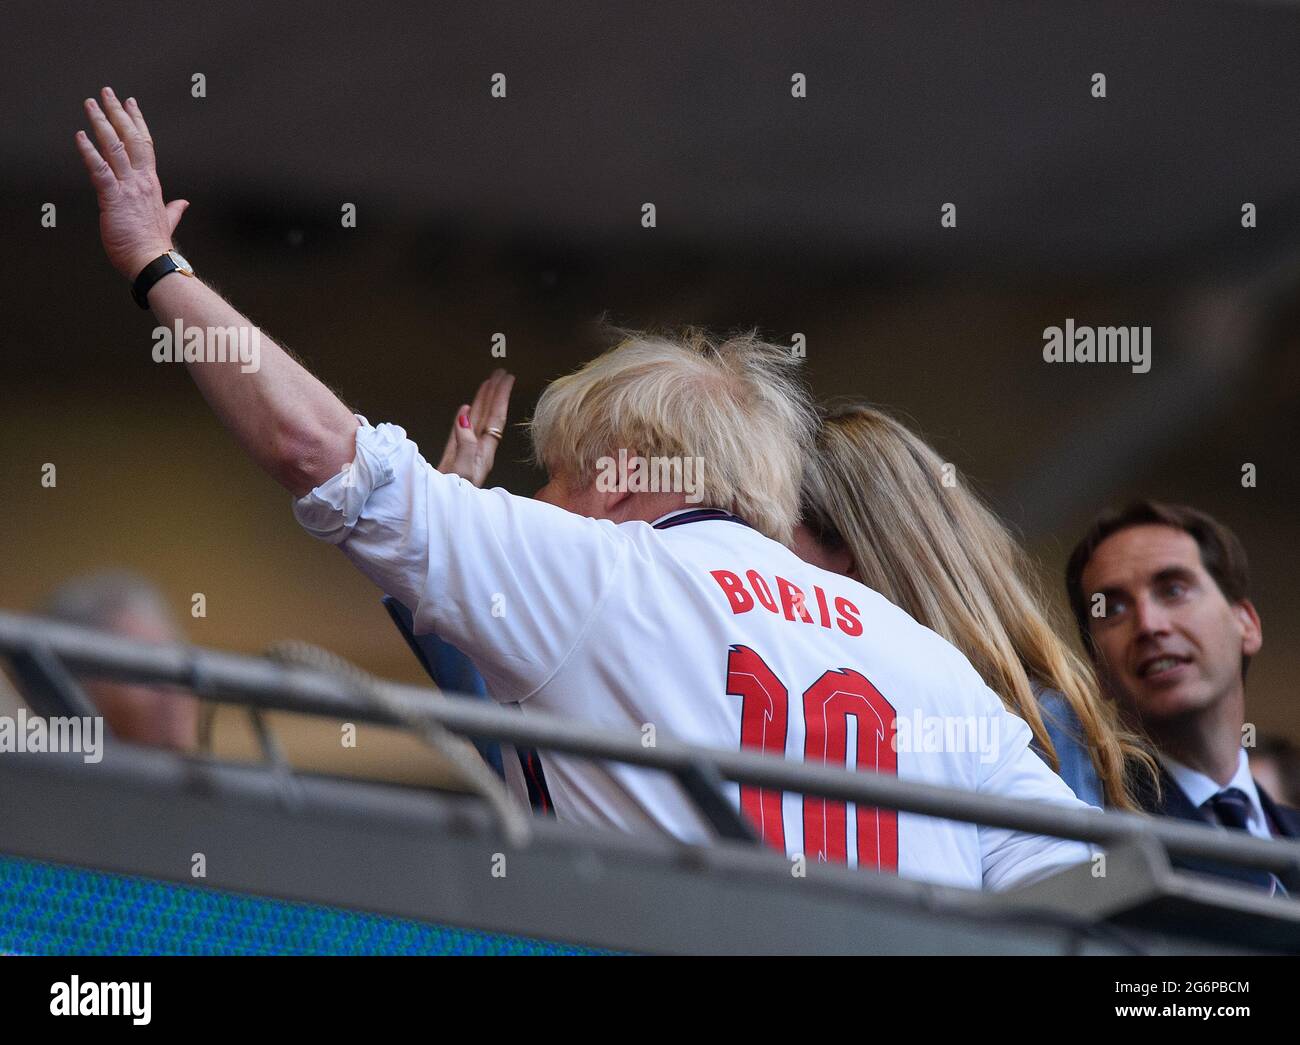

left=294, top=416, right=627, bottom=703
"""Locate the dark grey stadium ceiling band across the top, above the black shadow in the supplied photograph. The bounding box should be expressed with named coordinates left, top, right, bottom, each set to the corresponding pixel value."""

left=0, top=0, right=1300, bottom=278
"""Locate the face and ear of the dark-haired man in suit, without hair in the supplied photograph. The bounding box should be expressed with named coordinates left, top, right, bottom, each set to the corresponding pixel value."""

left=1080, top=524, right=1261, bottom=724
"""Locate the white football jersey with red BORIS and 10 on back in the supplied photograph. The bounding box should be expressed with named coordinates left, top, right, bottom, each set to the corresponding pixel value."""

left=294, top=417, right=1089, bottom=888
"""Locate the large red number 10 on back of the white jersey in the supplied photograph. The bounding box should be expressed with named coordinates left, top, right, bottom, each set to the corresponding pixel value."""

left=727, top=646, right=898, bottom=871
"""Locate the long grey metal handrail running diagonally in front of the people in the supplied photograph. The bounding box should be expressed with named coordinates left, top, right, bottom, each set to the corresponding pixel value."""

left=0, top=612, right=1300, bottom=890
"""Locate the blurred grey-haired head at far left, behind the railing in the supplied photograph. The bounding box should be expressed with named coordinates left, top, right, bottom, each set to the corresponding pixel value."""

left=42, top=571, right=198, bottom=750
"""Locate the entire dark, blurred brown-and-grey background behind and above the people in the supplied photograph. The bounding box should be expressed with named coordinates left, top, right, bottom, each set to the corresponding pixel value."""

left=0, top=0, right=1300, bottom=738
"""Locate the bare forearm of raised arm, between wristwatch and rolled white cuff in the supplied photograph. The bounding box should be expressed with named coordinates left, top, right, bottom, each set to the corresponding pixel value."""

left=150, top=273, right=358, bottom=497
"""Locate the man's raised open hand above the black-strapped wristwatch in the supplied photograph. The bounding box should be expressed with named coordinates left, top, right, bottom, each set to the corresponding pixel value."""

left=77, top=87, right=190, bottom=279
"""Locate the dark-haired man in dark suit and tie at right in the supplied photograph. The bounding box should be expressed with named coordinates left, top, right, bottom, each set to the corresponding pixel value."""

left=1066, top=500, right=1300, bottom=889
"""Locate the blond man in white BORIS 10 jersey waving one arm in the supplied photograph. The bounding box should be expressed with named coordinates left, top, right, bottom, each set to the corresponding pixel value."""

left=78, top=88, right=1088, bottom=888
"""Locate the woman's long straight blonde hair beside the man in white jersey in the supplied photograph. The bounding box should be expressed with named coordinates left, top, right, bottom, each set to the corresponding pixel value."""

left=803, top=404, right=1157, bottom=810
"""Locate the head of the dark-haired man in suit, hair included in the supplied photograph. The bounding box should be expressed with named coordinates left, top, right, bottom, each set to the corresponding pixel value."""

left=1066, top=500, right=1262, bottom=730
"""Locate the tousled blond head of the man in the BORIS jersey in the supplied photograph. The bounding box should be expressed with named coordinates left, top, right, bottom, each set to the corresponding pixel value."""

left=529, top=330, right=815, bottom=543
